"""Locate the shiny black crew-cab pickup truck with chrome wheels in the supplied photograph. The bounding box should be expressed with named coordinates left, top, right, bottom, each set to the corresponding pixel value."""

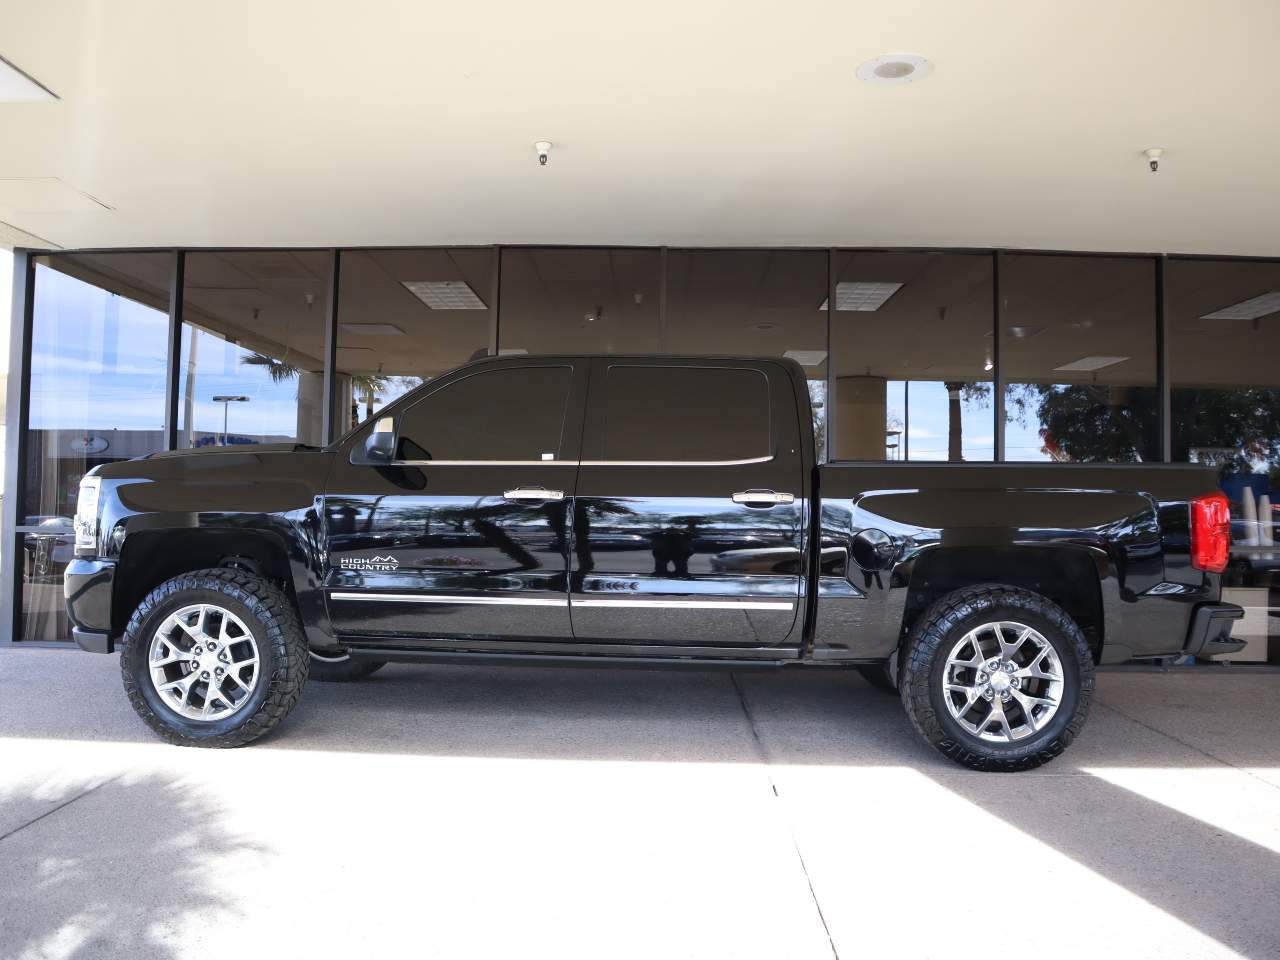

left=65, top=356, right=1242, bottom=771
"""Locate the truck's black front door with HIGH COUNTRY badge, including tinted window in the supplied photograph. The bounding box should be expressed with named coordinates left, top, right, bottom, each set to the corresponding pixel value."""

left=324, top=360, right=588, bottom=640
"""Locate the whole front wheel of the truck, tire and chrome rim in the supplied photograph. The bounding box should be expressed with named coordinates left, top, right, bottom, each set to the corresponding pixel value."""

left=120, top=568, right=310, bottom=746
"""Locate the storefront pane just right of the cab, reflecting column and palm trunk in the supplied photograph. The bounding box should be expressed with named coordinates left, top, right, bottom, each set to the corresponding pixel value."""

left=823, top=251, right=996, bottom=461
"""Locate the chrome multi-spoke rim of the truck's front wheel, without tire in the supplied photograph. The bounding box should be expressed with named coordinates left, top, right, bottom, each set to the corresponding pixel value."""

left=147, top=603, right=260, bottom=722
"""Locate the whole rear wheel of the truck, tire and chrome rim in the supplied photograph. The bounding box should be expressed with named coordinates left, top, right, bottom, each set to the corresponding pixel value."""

left=900, top=584, right=1093, bottom=772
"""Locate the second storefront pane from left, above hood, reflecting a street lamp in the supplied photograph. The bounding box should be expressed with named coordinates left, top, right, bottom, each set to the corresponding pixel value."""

left=179, top=256, right=329, bottom=448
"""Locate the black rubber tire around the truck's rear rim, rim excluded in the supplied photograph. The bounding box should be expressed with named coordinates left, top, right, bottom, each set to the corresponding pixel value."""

left=901, top=584, right=1093, bottom=772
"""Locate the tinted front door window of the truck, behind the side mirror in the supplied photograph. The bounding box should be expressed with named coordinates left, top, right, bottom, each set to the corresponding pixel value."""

left=398, top=366, right=572, bottom=460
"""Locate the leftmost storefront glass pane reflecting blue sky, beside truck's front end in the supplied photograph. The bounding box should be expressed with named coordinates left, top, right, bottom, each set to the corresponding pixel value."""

left=17, top=253, right=173, bottom=640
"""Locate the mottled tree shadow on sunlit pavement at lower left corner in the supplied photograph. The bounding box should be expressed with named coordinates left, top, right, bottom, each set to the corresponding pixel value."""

left=0, top=774, right=264, bottom=960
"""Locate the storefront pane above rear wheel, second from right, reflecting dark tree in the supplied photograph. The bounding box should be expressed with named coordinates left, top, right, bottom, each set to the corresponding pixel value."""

left=1000, top=253, right=1160, bottom=462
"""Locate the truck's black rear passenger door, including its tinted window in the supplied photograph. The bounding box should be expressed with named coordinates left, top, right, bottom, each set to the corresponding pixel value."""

left=570, top=358, right=805, bottom=648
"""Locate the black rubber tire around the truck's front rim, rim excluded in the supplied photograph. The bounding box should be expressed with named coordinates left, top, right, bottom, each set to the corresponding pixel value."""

left=120, top=567, right=311, bottom=748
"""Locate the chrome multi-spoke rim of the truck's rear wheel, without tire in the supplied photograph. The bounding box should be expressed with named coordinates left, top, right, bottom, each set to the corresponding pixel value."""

left=942, top=621, right=1065, bottom=744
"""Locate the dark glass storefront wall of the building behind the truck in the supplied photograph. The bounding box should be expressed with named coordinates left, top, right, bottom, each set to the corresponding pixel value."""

left=0, top=246, right=1280, bottom=659
